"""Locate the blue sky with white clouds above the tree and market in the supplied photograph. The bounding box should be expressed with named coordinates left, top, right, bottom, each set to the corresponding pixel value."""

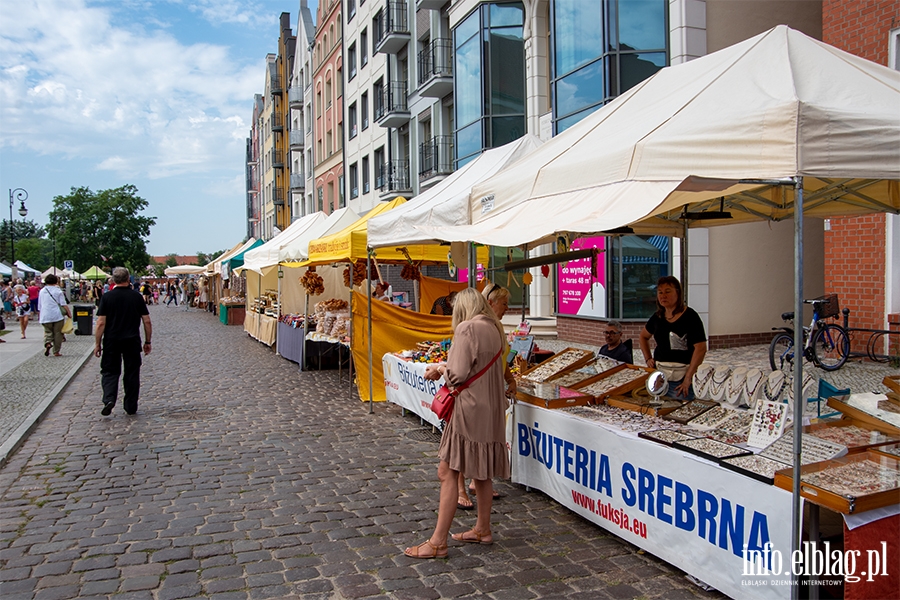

left=0, top=0, right=317, bottom=258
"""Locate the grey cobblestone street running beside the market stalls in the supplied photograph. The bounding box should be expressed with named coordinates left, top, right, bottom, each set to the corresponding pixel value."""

left=0, top=306, right=720, bottom=600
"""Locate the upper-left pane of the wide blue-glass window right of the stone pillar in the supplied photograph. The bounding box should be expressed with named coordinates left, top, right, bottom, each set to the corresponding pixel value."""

left=554, top=0, right=603, bottom=77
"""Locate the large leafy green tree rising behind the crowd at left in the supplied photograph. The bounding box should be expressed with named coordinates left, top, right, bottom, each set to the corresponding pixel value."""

left=47, top=185, right=156, bottom=274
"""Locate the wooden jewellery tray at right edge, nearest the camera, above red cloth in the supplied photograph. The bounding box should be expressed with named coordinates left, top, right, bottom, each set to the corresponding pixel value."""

left=775, top=450, right=900, bottom=515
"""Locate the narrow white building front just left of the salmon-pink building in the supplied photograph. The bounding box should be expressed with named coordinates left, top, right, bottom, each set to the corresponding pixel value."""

left=288, top=0, right=316, bottom=220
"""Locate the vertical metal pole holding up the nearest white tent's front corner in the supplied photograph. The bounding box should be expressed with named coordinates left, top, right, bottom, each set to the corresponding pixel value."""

left=791, top=175, right=813, bottom=600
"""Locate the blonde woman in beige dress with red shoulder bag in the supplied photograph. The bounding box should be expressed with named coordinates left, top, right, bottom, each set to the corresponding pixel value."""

left=404, top=288, right=509, bottom=558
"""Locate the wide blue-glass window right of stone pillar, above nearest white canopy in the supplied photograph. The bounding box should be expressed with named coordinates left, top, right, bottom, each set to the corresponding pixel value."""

left=550, top=0, right=668, bottom=134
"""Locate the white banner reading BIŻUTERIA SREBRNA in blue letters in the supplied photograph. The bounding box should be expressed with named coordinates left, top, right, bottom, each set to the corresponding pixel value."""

left=512, top=403, right=791, bottom=598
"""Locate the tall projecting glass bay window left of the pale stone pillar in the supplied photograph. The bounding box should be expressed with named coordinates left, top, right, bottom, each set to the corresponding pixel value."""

left=453, top=2, right=525, bottom=168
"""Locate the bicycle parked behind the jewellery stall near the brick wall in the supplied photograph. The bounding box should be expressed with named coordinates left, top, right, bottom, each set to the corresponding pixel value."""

left=769, top=294, right=850, bottom=371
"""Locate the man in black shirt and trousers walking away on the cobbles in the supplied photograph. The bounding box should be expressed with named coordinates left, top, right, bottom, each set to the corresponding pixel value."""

left=94, top=267, right=153, bottom=417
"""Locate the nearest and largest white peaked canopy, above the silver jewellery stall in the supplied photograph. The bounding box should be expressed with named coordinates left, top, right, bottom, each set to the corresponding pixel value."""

left=423, top=25, right=900, bottom=246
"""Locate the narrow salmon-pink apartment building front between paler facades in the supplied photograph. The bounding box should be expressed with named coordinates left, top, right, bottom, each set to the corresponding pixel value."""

left=313, top=0, right=346, bottom=214
